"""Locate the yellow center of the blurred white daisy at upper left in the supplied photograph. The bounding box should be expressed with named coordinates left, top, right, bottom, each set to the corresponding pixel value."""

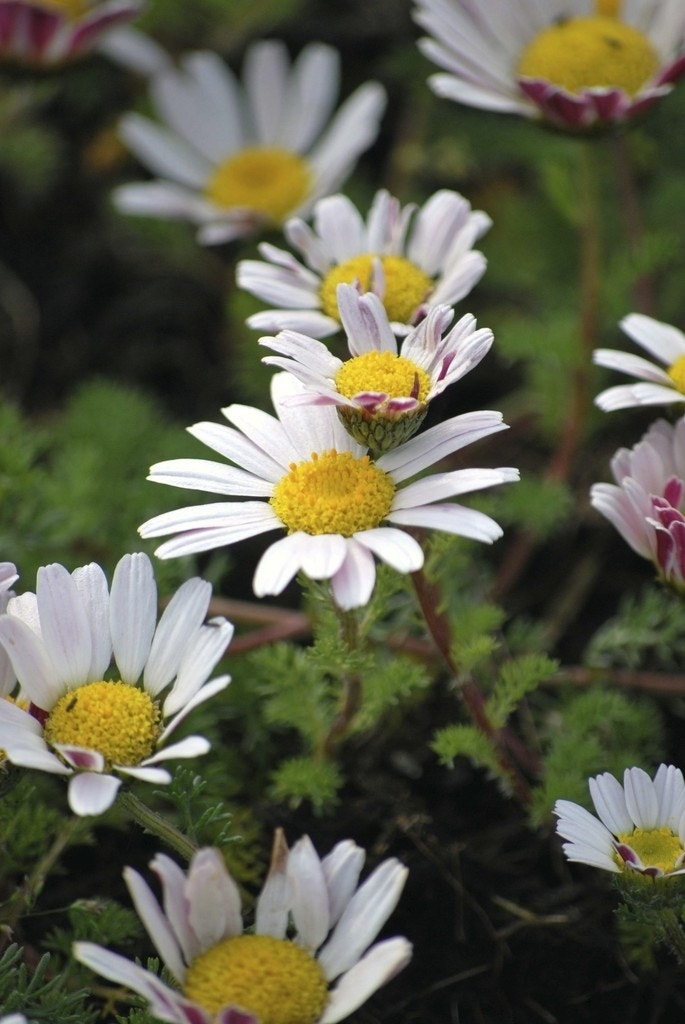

left=205, top=146, right=311, bottom=223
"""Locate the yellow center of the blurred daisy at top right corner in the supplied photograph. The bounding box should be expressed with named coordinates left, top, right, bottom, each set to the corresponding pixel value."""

left=517, top=15, right=659, bottom=96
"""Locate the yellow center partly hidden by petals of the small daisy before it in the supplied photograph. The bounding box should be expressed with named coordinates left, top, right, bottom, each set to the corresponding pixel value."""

left=318, top=254, right=433, bottom=324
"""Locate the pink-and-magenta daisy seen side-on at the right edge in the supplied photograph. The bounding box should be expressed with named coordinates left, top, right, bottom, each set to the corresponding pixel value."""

left=590, top=418, right=685, bottom=592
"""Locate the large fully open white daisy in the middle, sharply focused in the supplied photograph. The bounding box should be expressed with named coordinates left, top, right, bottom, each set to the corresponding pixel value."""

left=140, top=374, right=511, bottom=608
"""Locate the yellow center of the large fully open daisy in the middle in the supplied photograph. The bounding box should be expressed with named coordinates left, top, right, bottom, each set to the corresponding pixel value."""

left=269, top=450, right=395, bottom=537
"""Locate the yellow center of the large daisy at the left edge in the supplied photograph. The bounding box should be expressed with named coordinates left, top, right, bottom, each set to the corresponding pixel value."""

left=44, top=681, right=160, bottom=767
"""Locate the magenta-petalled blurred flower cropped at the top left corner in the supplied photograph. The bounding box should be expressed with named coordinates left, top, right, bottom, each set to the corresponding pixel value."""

left=0, top=0, right=141, bottom=66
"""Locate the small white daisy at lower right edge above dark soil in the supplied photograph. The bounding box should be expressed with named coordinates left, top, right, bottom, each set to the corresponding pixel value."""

left=554, top=765, right=685, bottom=878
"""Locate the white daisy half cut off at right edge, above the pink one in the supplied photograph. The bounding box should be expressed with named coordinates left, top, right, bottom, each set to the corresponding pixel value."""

left=594, top=313, right=685, bottom=413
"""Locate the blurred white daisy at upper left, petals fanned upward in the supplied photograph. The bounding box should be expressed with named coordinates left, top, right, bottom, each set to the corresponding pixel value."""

left=115, top=40, right=385, bottom=244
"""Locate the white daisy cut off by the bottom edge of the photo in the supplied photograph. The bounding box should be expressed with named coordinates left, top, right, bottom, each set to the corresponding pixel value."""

left=74, top=834, right=412, bottom=1024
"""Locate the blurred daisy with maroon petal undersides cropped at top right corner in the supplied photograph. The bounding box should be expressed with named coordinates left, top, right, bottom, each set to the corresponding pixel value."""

left=415, top=0, right=685, bottom=130
